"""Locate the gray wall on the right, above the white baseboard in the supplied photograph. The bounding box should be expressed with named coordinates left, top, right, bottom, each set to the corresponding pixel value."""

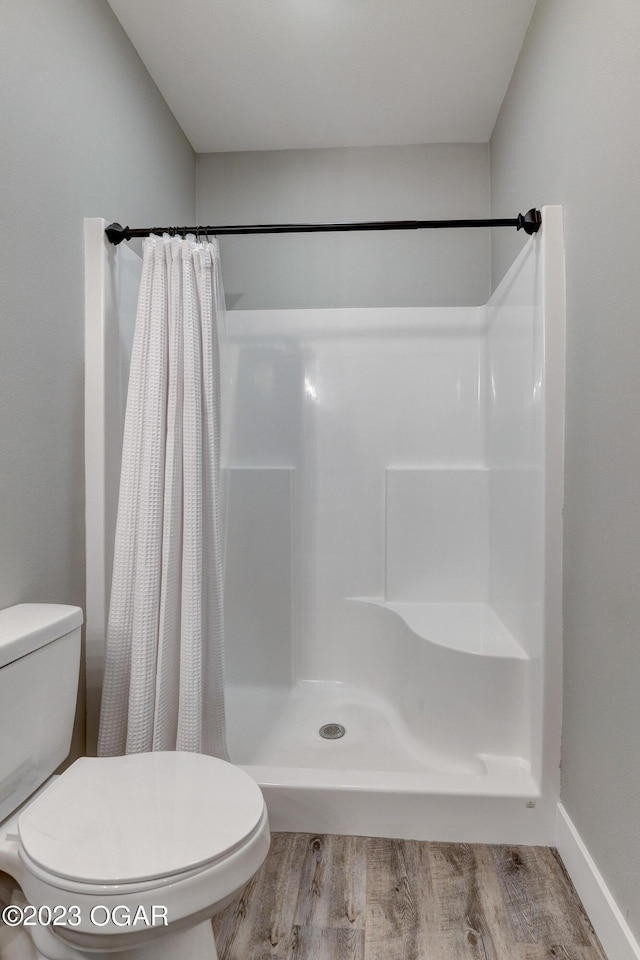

left=491, top=0, right=640, bottom=936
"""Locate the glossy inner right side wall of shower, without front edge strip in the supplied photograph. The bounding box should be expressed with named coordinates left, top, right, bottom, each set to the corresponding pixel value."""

left=486, top=262, right=544, bottom=655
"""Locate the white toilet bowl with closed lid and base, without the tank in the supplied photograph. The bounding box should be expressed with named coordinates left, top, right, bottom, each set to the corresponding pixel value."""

left=0, top=604, right=270, bottom=960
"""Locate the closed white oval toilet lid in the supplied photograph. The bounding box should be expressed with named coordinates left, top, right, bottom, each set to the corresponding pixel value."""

left=18, top=753, right=264, bottom=884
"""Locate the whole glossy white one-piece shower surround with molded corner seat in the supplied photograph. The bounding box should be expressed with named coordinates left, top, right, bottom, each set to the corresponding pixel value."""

left=87, top=207, right=564, bottom=843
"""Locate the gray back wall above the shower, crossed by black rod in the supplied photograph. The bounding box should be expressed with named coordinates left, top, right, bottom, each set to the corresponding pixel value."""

left=197, top=144, right=491, bottom=309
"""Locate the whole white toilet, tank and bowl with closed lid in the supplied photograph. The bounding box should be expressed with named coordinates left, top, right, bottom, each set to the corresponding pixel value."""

left=0, top=604, right=270, bottom=960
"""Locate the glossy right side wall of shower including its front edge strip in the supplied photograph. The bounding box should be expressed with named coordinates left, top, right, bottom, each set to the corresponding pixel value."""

left=486, top=206, right=565, bottom=789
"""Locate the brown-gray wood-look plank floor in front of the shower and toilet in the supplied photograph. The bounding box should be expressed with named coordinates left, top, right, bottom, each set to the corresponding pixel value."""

left=214, top=833, right=606, bottom=960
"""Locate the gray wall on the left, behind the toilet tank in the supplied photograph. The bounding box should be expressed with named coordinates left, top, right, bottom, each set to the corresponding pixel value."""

left=0, top=0, right=195, bottom=752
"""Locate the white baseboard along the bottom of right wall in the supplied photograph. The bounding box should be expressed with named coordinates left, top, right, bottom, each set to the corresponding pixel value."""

left=556, top=803, right=640, bottom=960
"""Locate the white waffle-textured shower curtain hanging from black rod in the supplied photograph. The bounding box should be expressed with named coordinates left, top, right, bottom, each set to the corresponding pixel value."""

left=98, top=235, right=228, bottom=758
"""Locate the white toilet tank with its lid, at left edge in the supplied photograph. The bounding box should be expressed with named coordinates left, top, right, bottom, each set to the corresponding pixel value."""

left=0, top=603, right=82, bottom=821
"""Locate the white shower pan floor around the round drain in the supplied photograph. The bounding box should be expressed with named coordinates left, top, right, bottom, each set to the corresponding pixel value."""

left=227, top=681, right=535, bottom=794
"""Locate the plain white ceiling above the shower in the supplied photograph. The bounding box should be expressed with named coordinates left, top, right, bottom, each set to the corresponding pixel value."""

left=109, top=0, right=535, bottom=153
